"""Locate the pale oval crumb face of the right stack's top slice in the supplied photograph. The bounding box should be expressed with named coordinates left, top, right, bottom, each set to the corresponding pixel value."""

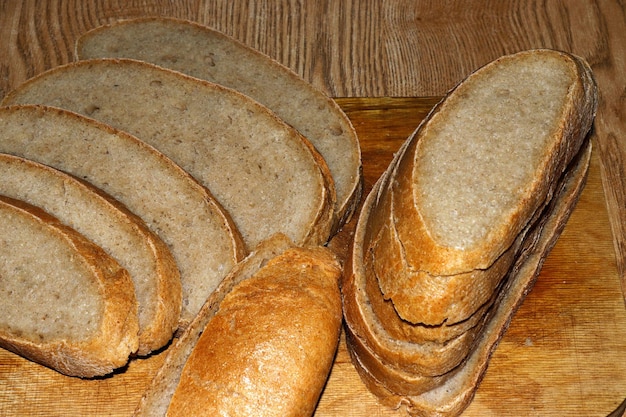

left=413, top=54, right=576, bottom=248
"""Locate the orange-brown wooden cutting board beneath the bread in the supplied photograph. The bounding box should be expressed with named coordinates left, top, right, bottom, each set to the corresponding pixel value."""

left=0, top=97, right=626, bottom=417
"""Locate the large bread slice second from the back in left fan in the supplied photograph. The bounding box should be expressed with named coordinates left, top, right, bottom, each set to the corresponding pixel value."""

left=4, top=59, right=335, bottom=249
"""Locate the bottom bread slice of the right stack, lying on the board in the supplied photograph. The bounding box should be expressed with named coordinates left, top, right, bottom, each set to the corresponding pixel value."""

left=349, top=141, right=591, bottom=417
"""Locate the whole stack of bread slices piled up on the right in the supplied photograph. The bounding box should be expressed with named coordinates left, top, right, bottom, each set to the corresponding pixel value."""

left=342, top=50, right=597, bottom=416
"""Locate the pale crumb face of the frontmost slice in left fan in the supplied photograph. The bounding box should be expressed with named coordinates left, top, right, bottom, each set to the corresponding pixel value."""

left=0, top=205, right=104, bottom=341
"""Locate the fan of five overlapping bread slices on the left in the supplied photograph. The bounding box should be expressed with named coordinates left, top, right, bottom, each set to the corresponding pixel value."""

left=0, top=15, right=362, bottom=394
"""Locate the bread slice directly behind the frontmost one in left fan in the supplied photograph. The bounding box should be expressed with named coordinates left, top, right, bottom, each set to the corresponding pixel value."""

left=0, top=154, right=182, bottom=355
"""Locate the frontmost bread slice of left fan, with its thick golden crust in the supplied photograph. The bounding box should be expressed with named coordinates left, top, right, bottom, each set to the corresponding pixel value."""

left=0, top=196, right=139, bottom=377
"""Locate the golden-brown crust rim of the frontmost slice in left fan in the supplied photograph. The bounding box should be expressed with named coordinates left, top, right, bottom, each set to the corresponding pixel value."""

left=0, top=196, right=139, bottom=377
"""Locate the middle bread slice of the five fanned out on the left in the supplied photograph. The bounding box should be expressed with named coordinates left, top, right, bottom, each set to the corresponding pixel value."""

left=0, top=106, right=244, bottom=327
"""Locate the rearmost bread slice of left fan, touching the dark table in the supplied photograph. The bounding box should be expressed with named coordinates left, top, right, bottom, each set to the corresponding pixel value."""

left=76, top=17, right=362, bottom=231
